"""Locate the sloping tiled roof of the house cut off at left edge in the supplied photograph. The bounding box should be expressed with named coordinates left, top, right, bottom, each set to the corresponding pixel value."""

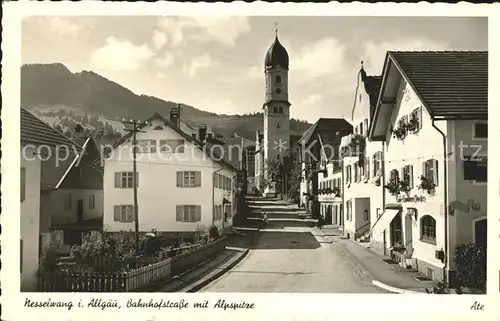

left=21, top=108, right=81, bottom=151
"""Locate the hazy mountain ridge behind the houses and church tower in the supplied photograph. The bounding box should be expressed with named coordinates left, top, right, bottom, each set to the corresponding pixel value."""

left=21, top=63, right=310, bottom=140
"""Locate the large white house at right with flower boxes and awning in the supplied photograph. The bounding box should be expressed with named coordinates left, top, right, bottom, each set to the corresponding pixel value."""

left=368, top=51, right=488, bottom=281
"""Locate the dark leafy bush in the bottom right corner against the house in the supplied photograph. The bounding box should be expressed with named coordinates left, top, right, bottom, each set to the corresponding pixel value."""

left=453, top=244, right=486, bottom=290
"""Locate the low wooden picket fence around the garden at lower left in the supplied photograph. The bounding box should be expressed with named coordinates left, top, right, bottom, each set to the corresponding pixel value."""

left=38, top=239, right=226, bottom=292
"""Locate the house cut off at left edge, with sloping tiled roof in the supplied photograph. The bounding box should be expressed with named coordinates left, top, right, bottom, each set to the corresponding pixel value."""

left=20, top=108, right=81, bottom=291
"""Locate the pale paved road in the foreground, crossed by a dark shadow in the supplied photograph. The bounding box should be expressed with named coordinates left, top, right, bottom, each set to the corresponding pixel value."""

left=201, top=228, right=383, bottom=293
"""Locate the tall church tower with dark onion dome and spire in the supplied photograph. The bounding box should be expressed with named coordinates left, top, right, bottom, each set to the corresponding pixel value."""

left=262, top=29, right=290, bottom=165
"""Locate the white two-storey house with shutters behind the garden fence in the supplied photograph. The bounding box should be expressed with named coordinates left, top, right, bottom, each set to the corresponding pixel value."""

left=103, top=109, right=238, bottom=233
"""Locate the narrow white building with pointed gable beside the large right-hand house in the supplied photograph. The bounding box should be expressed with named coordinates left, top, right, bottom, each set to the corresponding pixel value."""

left=340, top=65, right=384, bottom=241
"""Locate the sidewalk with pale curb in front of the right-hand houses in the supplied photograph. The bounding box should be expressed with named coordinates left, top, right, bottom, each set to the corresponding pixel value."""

left=318, top=226, right=437, bottom=294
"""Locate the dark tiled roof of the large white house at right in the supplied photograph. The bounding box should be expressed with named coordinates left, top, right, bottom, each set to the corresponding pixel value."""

left=386, top=51, right=488, bottom=119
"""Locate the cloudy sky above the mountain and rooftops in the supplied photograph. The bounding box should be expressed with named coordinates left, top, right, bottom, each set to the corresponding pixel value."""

left=22, top=16, right=488, bottom=122
